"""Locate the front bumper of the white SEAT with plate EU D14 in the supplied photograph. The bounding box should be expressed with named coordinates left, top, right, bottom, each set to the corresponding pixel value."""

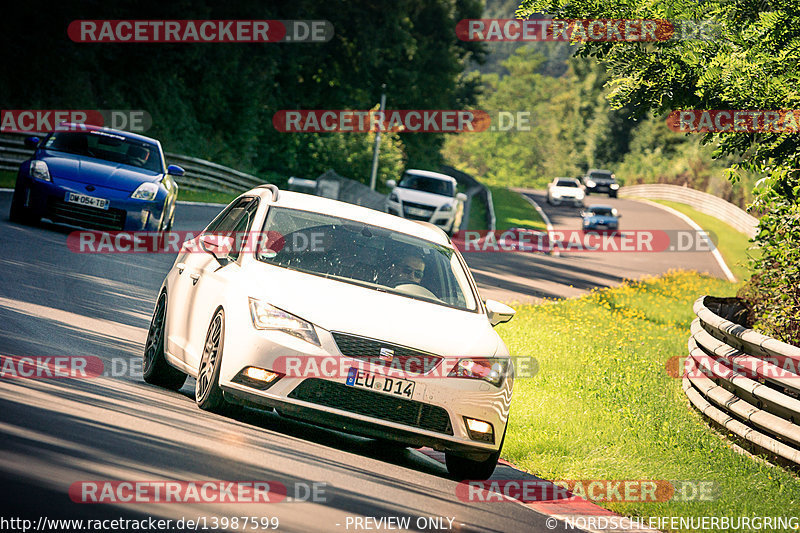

left=220, top=328, right=513, bottom=459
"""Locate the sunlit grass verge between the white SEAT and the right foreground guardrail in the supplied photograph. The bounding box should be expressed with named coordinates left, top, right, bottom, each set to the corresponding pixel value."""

left=497, top=271, right=800, bottom=528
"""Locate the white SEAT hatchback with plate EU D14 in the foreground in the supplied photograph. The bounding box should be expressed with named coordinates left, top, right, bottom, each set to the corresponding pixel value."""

left=143, top=185, right=514, bottom=479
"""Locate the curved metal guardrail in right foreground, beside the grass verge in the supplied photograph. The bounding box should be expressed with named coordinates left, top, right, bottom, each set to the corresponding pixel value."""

left=683, top=296, right=800, bottom=465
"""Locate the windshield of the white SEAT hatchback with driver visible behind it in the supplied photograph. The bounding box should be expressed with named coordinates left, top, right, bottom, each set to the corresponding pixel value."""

left=257, top=207, right=477, bottom=311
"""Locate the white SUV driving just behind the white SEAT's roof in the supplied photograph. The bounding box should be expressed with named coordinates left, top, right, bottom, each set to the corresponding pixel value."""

left=386, top=170, right=467, bottom=234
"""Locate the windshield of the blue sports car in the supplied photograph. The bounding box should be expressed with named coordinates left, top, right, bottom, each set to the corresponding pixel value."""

left=44, top=131, right=164, bottom=172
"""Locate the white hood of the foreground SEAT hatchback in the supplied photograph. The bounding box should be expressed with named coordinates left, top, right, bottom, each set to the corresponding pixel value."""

left=246, top=262, right=498, bottom=357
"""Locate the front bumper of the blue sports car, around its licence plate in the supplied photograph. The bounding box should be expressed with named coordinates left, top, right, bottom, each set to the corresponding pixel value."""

left=16, top=174, right=167, bottom=231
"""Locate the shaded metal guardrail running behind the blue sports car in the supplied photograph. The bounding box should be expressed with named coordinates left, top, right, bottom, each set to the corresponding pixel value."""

left=0, top=132, right=265, bottom=192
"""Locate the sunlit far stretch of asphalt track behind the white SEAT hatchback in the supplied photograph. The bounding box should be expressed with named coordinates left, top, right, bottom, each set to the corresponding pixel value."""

left=464, top=190, right=724, bottom=303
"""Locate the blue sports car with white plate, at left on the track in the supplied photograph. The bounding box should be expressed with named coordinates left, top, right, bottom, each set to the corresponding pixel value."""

left=10, top=125, right=184, bottom=231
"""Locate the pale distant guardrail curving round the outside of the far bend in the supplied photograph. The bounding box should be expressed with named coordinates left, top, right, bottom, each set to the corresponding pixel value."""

left=619, top=184, right=758, bottom=238
